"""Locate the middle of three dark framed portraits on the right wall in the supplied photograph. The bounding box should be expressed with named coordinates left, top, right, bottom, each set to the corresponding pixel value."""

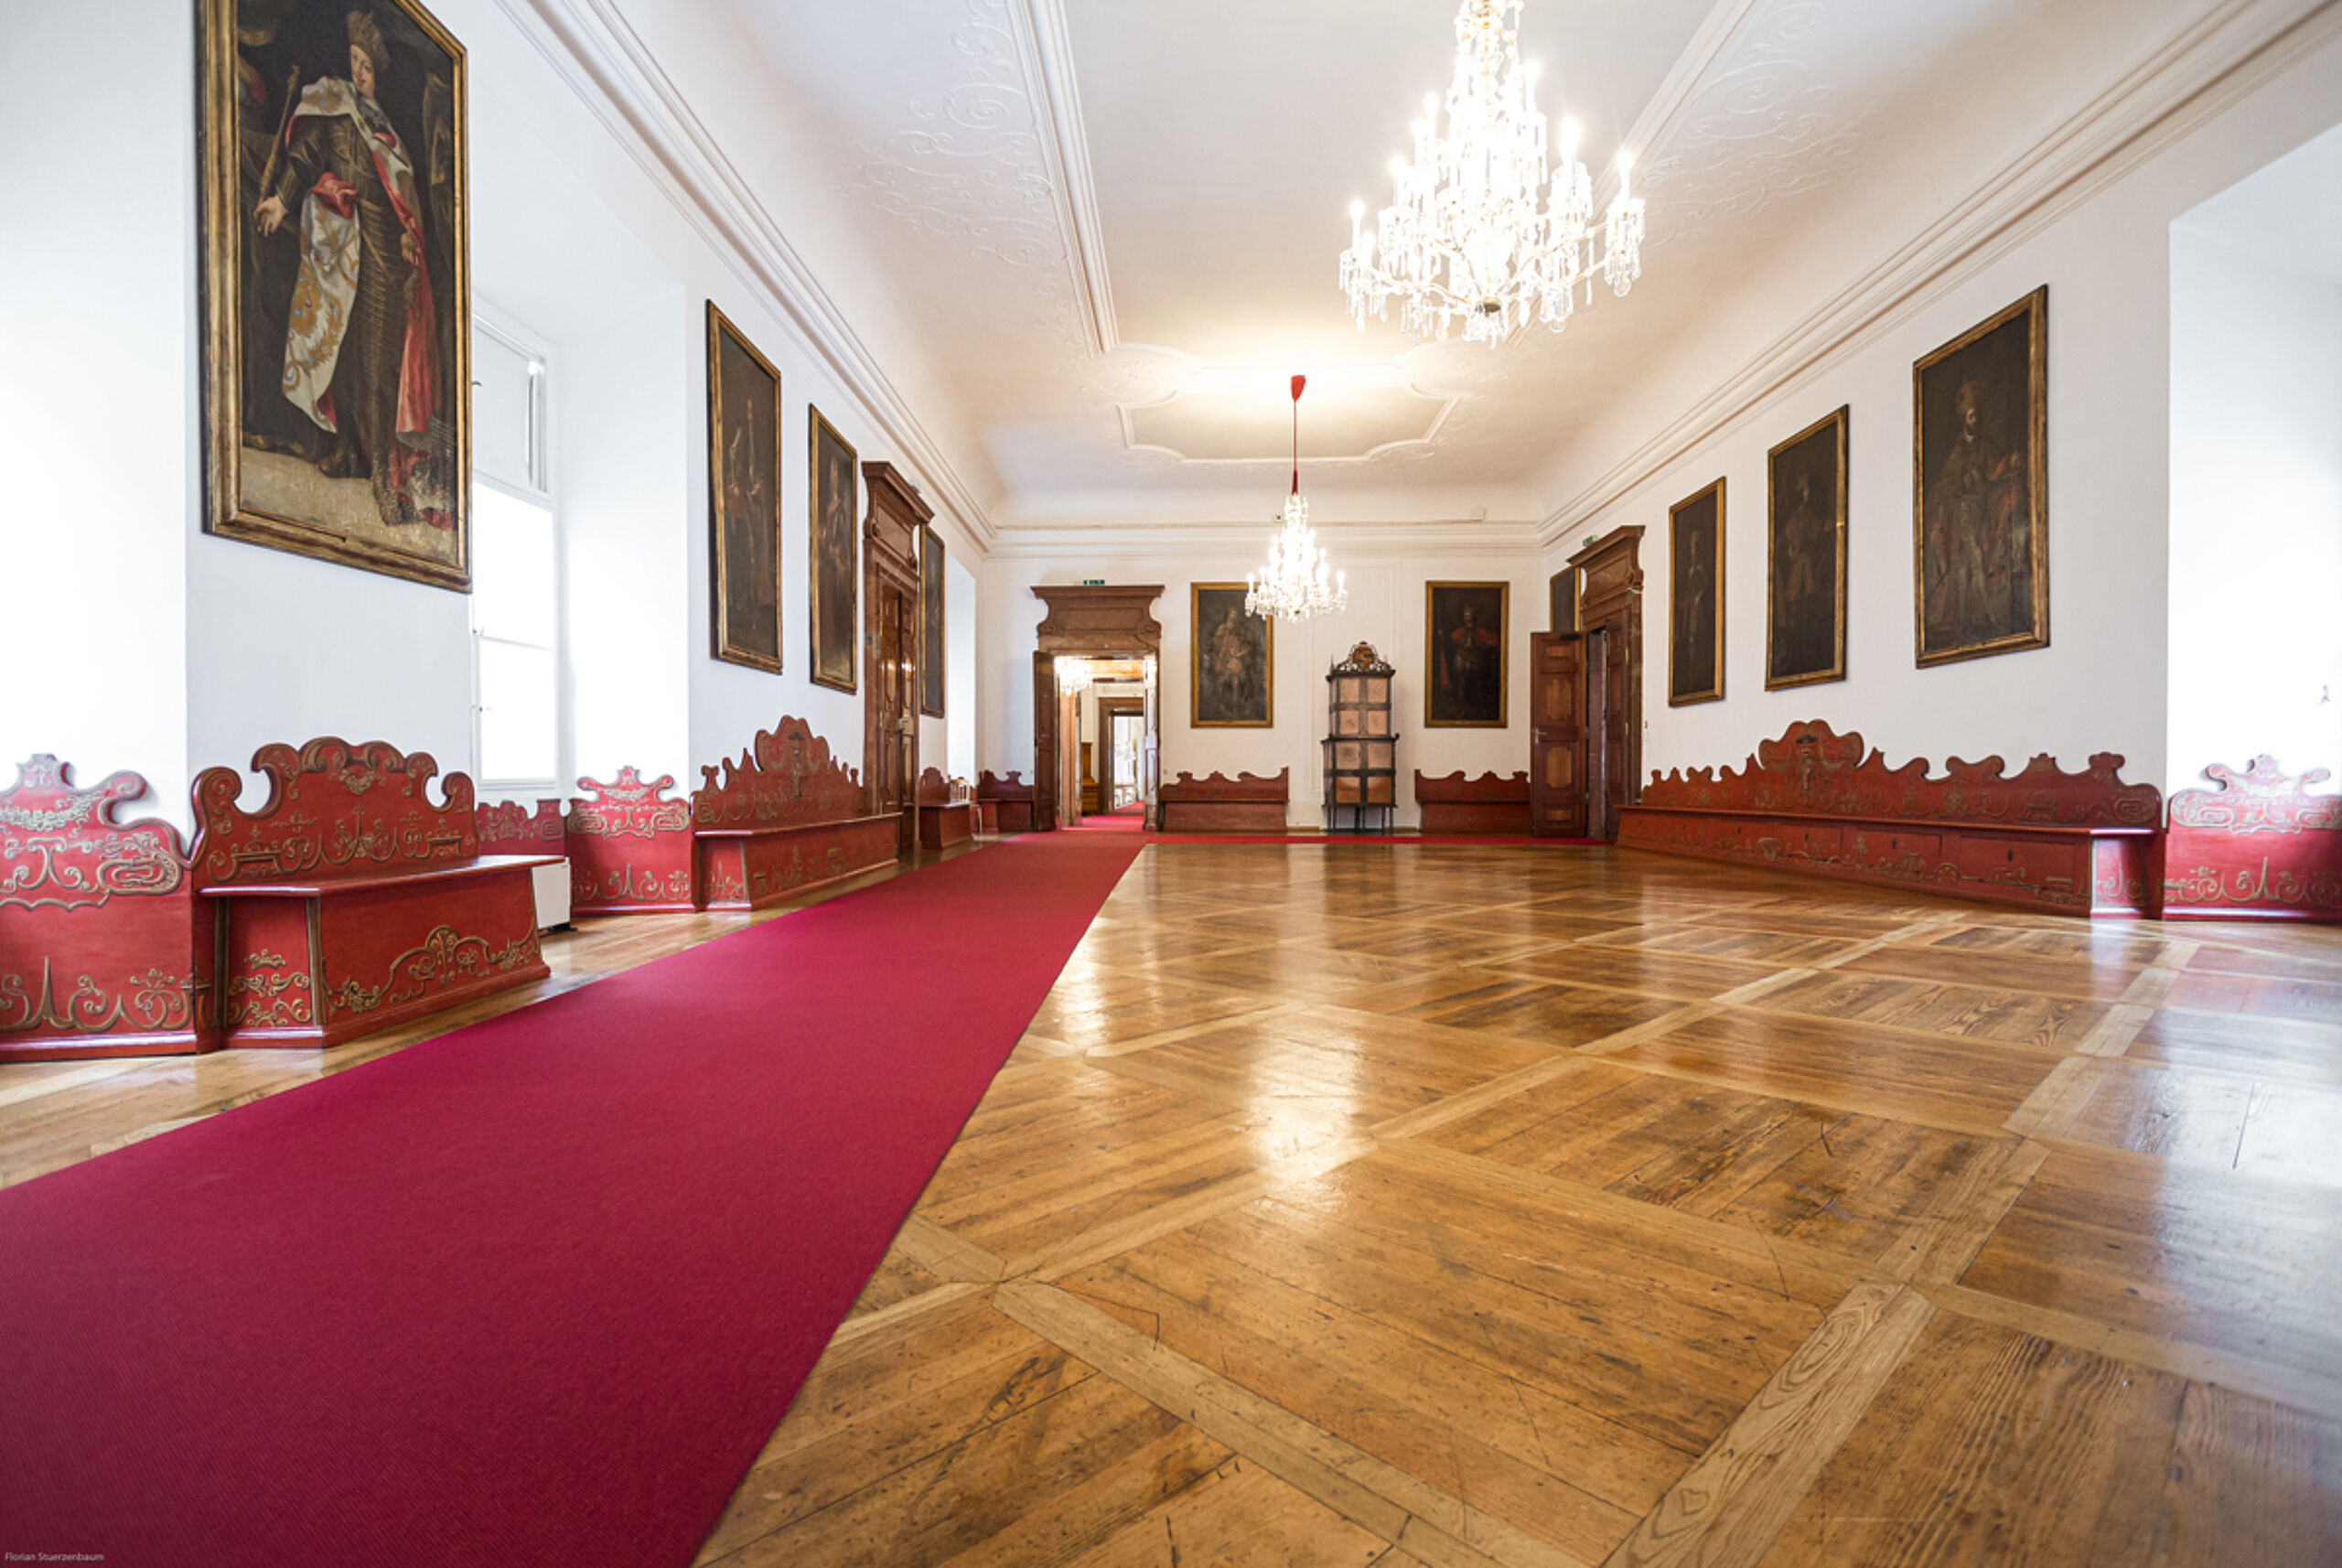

left=1764, top=407, right=1850, bottom=691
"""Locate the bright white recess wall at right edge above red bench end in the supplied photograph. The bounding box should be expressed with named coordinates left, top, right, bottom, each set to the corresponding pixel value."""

left=2169, top=227, right=2342, bottom=789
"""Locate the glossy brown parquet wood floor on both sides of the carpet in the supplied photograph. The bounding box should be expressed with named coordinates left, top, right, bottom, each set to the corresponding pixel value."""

left=0, top=845, right=2342, bottom=1568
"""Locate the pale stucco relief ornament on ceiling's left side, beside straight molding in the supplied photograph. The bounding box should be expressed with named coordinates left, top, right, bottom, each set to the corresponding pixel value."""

left=850, top=0, right=1072, bottom=328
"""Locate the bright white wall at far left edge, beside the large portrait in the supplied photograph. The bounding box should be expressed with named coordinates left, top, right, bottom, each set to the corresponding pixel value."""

left=0, top=0, right=201, bottom=826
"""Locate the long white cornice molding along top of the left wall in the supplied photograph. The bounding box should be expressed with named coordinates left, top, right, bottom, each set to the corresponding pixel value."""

left=497, top=0, right=998, bottom=554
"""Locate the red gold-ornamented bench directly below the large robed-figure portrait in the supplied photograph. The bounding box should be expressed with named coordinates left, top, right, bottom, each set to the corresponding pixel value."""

left=189, top=737, right=557, bottom=1047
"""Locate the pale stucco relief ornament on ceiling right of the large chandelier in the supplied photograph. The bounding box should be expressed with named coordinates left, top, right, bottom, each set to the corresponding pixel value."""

left=1644, top=0, right=1862, bottom=251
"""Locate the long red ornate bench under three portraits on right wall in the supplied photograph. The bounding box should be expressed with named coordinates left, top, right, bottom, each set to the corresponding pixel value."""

left=1618, top=723, right=2162, bottom=915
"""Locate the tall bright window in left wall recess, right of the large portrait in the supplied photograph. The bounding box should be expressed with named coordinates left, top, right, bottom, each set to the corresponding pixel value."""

left=471, top=320, right=560, bottom=798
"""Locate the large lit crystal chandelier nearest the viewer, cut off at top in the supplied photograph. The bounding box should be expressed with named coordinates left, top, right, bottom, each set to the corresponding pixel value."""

left=1342, top=0, right=1642, bottom=344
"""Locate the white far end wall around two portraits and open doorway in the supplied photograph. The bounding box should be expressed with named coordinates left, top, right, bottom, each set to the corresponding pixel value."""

left=982, top=540, right=1546, bottom=826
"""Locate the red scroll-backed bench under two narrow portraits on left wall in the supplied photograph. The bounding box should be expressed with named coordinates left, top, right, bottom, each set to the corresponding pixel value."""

left=691, top=718, right=897, bottom=910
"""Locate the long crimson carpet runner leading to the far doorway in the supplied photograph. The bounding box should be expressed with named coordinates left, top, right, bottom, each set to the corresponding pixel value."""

left=0, top=833, right=1145, bottom=1568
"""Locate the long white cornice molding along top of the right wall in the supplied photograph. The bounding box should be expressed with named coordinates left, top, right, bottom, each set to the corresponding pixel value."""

left=1539, top=0, right=2342, bottom=548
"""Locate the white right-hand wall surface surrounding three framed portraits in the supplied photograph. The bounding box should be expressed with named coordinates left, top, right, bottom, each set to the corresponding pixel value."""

left=1546, top=23, right=2342, bottom=784
